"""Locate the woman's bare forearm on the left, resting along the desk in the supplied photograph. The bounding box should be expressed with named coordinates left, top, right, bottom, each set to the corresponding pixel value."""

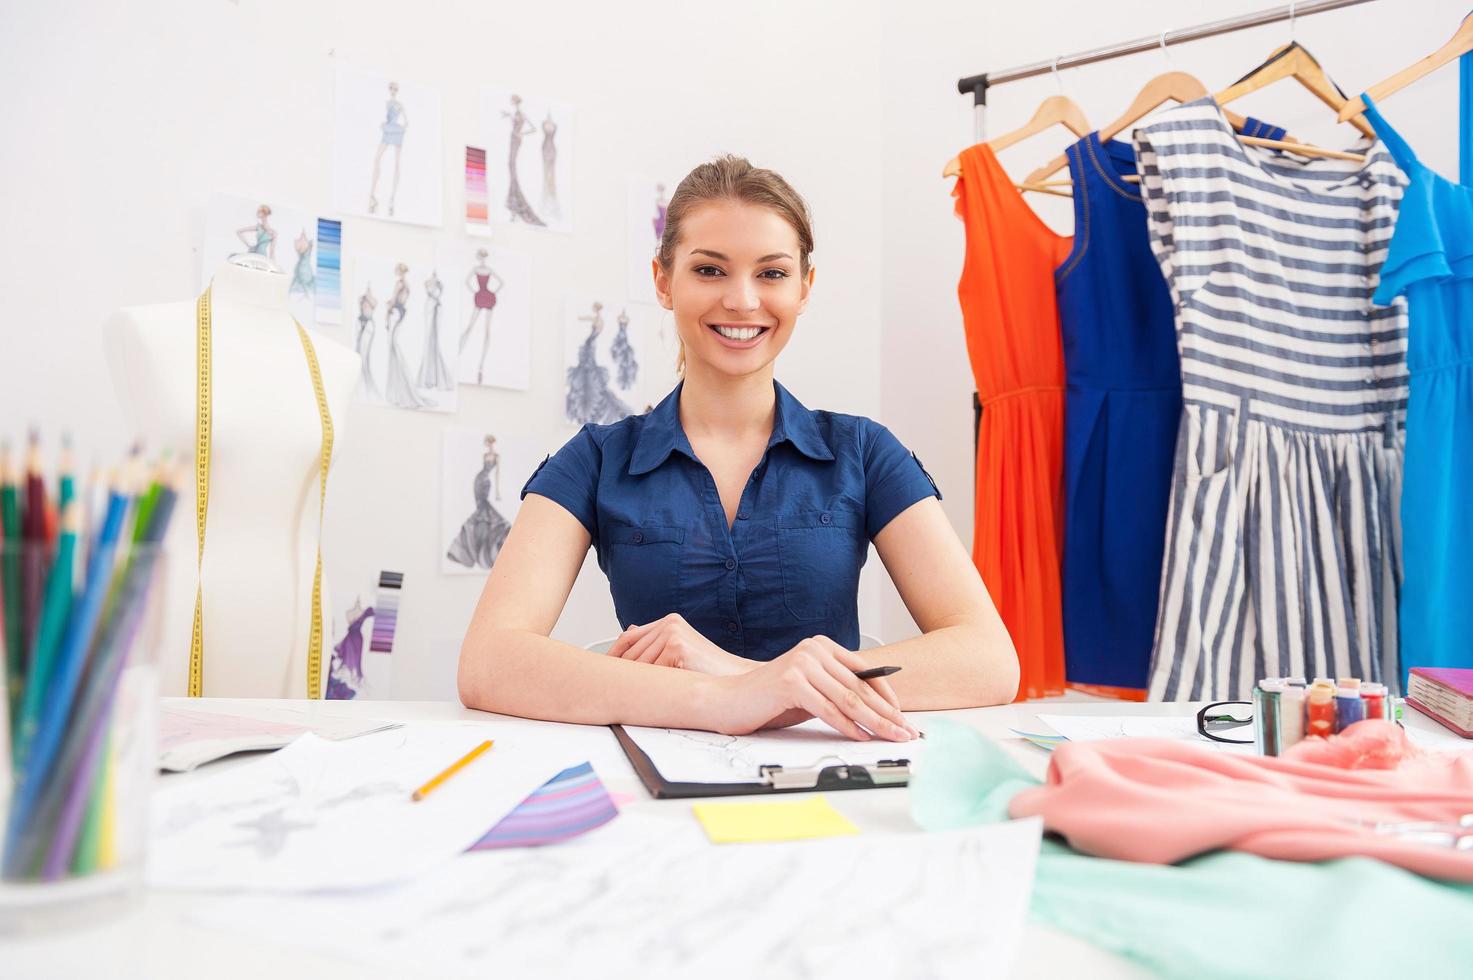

left=457, top=629, right=719, bottom=731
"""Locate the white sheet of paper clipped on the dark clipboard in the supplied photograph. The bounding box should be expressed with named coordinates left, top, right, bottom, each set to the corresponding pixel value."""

left=625, top=719, right=925, bottom=783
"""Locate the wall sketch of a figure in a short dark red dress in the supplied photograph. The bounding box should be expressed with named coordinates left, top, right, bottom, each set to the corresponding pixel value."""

left=440, top=242, right=532, bottom=391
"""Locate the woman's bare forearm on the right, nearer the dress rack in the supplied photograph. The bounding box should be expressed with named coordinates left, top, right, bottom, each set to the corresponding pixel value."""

left=859, top=623, right=1018, bottom=712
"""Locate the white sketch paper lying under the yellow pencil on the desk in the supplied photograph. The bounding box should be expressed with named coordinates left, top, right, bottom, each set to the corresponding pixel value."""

left=149, top=722, right=586, bottom=892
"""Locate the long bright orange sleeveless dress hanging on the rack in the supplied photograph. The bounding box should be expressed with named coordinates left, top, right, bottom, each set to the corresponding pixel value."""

left=952, top=143, right=1072, bottom=700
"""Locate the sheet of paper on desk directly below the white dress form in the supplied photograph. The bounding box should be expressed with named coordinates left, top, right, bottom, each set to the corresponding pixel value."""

left=159, top=704, right=398, bottom=772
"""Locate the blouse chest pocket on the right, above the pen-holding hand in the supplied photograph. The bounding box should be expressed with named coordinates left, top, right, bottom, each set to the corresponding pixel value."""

left=778, top=510, right=860, bottom=622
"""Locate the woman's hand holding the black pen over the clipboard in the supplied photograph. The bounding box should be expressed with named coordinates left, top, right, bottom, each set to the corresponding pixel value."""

left=713, top=637, right=919, bottom=741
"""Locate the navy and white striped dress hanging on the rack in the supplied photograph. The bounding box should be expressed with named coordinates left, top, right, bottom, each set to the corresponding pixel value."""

left=1136, top=99, right=1407, bottom=700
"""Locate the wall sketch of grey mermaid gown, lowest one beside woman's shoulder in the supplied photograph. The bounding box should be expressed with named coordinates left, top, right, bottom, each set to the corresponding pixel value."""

left=440, top=426, right=542, bottom=575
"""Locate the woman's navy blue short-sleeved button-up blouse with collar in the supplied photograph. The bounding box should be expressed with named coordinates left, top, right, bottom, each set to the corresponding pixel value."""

left=521, top=385, right=941, bottom=660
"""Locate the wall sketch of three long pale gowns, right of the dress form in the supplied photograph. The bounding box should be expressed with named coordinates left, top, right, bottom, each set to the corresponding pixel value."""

left=351, top=255, right=457, bottom=411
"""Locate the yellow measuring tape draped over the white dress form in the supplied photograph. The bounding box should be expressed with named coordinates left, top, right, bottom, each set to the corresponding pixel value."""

left=189, top=289, right=333, bottom=699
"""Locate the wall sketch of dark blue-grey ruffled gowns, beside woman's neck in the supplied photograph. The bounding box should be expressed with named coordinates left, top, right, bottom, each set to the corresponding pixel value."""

left=564, top=296, right=678, bottom=426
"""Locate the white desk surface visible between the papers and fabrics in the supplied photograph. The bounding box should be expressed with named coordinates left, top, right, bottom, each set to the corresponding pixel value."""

left=11, top=699, right=1455, bottom=980
